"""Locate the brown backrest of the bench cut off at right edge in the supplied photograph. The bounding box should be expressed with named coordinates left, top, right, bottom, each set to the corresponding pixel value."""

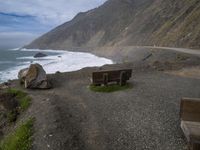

left=180, top=98, right=200, bottom=122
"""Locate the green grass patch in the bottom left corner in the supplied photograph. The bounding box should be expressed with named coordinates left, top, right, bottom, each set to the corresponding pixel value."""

left=0, top=118, right=34, bottom=150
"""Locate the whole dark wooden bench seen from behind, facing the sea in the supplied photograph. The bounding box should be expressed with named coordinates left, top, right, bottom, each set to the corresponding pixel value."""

left=92, top=69, right=132, bottom=86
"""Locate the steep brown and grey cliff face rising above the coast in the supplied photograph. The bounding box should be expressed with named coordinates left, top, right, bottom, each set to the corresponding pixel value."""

left=26, top=0, right=200, bottom=49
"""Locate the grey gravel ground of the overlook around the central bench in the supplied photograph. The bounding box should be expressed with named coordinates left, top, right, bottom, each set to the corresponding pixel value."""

left=11, top=63, right=200, bottom=150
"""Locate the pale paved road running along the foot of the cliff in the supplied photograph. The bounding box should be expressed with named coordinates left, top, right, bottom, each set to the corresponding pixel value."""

left=143, top=46, right=200, bottom=57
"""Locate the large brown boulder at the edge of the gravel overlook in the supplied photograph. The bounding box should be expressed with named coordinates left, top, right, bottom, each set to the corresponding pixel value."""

left=18, top=64, right=51, bottom=89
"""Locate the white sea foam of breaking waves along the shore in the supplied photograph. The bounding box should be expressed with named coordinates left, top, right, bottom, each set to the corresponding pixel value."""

left=0, top=49, right=113, bottom=81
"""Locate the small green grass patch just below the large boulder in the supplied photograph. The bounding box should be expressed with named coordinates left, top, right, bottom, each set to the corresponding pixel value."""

left=7, top=88, right=31, bottom=111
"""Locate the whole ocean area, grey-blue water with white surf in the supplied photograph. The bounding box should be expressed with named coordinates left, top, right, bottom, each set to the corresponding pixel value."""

left=0, top=49, right=113, bottom=83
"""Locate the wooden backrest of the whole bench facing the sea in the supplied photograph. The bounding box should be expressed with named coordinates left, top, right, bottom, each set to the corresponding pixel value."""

left=92, top=69, right=132, bottom=82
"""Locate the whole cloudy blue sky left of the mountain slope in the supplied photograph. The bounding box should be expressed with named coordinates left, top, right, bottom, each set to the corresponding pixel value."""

left=0, top=0, right=106, bottom=48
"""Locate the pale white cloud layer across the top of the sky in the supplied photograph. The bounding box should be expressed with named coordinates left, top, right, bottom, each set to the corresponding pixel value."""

left=0, top=0, right=106, bottom=25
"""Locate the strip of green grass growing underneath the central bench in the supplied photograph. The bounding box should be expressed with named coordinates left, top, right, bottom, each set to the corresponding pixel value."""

left=89, top=84, right=132, bottom=93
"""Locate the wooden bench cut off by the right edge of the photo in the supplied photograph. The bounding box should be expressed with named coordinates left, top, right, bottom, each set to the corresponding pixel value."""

left=180, top=98, right=200, bottom=150
